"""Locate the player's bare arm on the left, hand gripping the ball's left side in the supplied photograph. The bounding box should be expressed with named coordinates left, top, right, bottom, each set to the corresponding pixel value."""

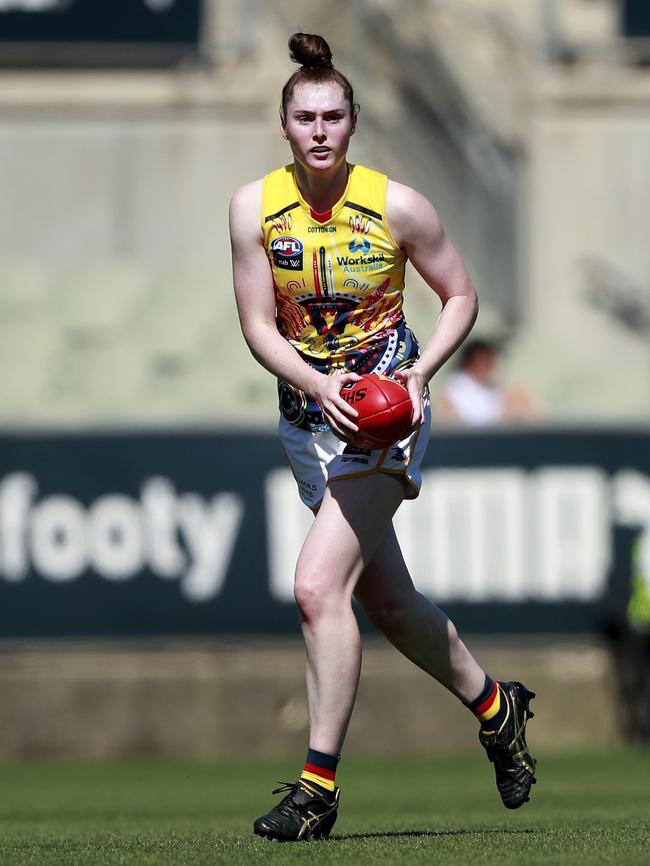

left=230, top=180, right=360, bottom=439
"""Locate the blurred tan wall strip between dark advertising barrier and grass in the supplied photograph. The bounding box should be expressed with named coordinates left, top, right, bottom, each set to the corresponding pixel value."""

left=0, top=626, right=624, bottom=760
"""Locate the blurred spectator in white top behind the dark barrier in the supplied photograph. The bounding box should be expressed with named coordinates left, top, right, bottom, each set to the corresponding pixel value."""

left=438, top=340, right=537, bottom=426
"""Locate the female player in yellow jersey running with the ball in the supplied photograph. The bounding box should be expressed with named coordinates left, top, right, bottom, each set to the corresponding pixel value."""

left=230, top=33, right=535, bottom=840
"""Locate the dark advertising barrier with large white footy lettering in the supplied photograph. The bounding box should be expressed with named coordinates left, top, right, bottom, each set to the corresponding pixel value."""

left=0, top=430, right=650, bottom=637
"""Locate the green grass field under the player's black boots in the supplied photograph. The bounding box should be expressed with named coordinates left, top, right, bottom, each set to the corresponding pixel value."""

left=0, top=751, right=650, bottom=866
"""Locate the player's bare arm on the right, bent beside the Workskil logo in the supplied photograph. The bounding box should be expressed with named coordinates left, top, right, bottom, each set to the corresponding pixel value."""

left=386, top=181, right=478, bottom=424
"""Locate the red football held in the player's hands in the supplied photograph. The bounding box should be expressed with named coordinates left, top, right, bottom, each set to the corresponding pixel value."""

left=341, top=373, right=412, bottom=449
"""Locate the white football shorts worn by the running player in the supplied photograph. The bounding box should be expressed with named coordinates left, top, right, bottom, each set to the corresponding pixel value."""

left=279, top=400, right=431, bottom=508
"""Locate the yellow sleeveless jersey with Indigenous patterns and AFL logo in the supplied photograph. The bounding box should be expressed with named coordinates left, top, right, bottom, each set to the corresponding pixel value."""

left=262, top=165, right=418, bottom=430
